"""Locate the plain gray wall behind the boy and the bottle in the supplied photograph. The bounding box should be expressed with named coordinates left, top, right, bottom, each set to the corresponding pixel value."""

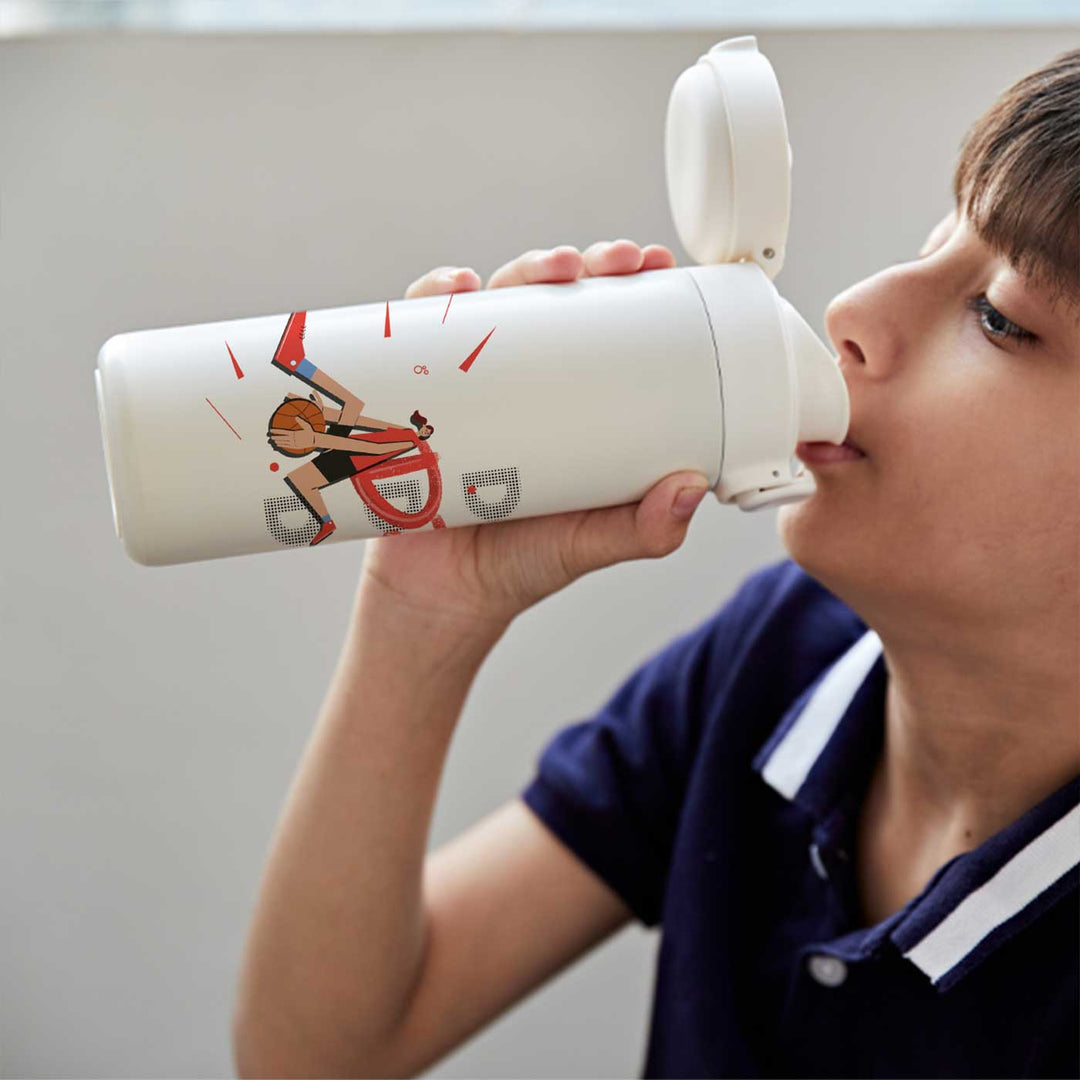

left=0, top=25, right=1080, bottom=1077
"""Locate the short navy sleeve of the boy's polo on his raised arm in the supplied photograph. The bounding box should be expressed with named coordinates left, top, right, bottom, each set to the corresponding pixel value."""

left=521, top=567, right=777, bottom=927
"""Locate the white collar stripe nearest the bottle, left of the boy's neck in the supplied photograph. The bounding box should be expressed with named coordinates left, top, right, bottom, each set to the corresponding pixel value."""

left=761, top=630, right=881, bottom=799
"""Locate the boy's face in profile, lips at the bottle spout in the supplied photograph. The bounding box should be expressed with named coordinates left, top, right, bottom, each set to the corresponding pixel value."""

left=778, top=211, right=1080, bottom=629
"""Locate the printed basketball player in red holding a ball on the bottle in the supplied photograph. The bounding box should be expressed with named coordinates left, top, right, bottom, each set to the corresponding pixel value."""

left=267, top=311, right=435, bottom=546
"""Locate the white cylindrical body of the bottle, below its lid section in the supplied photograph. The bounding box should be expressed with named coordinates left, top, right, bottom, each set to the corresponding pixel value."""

left=95, top=264, right=847, bottom=566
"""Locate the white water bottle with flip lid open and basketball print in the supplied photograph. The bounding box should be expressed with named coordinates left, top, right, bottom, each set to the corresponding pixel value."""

left=95, top=36, right=849, bottom=566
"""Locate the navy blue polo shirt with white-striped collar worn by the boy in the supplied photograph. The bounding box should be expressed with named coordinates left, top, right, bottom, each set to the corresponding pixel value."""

left=522, top=559, right=1080, bottom=1077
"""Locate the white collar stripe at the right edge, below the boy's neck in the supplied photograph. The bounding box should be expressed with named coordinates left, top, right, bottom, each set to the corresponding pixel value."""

left=903, top=806, right=1080, bottom=983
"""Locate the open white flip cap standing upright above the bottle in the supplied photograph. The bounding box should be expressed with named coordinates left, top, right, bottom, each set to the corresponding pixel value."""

left=664, top=35, right=792, bottom=281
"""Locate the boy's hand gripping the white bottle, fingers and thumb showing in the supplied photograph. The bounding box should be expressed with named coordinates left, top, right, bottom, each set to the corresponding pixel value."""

left=357, top=240, right=706, bottom=627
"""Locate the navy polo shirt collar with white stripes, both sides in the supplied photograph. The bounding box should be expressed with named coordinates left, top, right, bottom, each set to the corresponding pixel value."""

left=753, top=630, right=1080, bottom=991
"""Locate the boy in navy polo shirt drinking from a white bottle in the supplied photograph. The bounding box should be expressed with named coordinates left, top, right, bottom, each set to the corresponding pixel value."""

left=233, top=51, right=1080, bottom=1077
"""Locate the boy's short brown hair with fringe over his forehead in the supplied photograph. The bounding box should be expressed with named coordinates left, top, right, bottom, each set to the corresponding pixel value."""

left=953, top=49, right=1080, bottom=308
